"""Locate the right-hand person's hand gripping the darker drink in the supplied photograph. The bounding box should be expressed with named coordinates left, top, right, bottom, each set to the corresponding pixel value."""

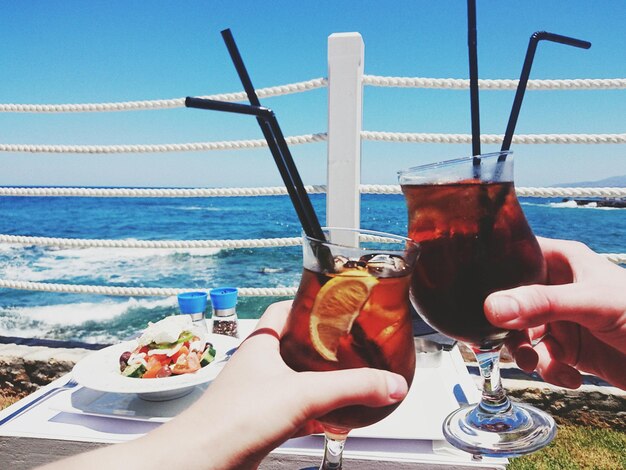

left=485, top=238, right=626, bottom=389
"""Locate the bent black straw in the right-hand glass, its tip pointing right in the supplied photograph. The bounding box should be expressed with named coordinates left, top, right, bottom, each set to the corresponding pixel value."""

left=498, top=31, right=591, bottom=162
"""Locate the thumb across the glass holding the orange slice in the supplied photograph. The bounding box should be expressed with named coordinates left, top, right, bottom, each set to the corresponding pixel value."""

left=300, top=368, right=409, bottom=418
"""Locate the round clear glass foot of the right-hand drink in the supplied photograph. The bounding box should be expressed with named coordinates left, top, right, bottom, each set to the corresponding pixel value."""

left=443, top=403, right=556, bottom=457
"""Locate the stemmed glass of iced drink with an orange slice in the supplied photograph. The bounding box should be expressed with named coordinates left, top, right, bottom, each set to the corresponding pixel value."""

left=280, top=228, right=418, bottom=469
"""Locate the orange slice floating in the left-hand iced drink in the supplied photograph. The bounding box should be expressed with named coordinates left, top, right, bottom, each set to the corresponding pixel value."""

left=309, top=270, right=378, bottom=362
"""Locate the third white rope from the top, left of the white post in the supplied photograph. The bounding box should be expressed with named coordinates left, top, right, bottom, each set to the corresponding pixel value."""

left=0, top=185, right=326, bottom=198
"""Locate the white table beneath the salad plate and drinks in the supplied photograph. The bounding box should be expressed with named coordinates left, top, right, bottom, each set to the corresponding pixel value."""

left=0, top=320, right=507, bottom=470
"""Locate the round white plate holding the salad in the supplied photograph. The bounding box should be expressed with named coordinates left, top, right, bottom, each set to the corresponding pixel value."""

left=72, top=335, right=241, bottom=401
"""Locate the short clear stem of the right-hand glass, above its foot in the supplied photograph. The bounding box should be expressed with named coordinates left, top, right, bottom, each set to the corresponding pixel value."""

left=472, top=345, right=511, bottom=414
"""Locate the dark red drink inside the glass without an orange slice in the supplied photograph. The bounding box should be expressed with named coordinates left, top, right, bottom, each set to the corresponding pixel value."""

left=402, top=179, right=546, bottom=348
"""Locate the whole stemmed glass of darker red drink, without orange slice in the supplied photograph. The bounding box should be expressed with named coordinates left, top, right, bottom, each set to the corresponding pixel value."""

left=399, top=152, right=556, bottom=457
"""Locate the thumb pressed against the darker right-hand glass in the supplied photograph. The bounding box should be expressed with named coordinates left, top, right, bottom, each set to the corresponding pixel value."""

left=485, top=283, right=626, bottom=346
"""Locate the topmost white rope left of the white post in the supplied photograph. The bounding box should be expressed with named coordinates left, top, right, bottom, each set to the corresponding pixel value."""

left=0, top=78, right=328, bottom=113
